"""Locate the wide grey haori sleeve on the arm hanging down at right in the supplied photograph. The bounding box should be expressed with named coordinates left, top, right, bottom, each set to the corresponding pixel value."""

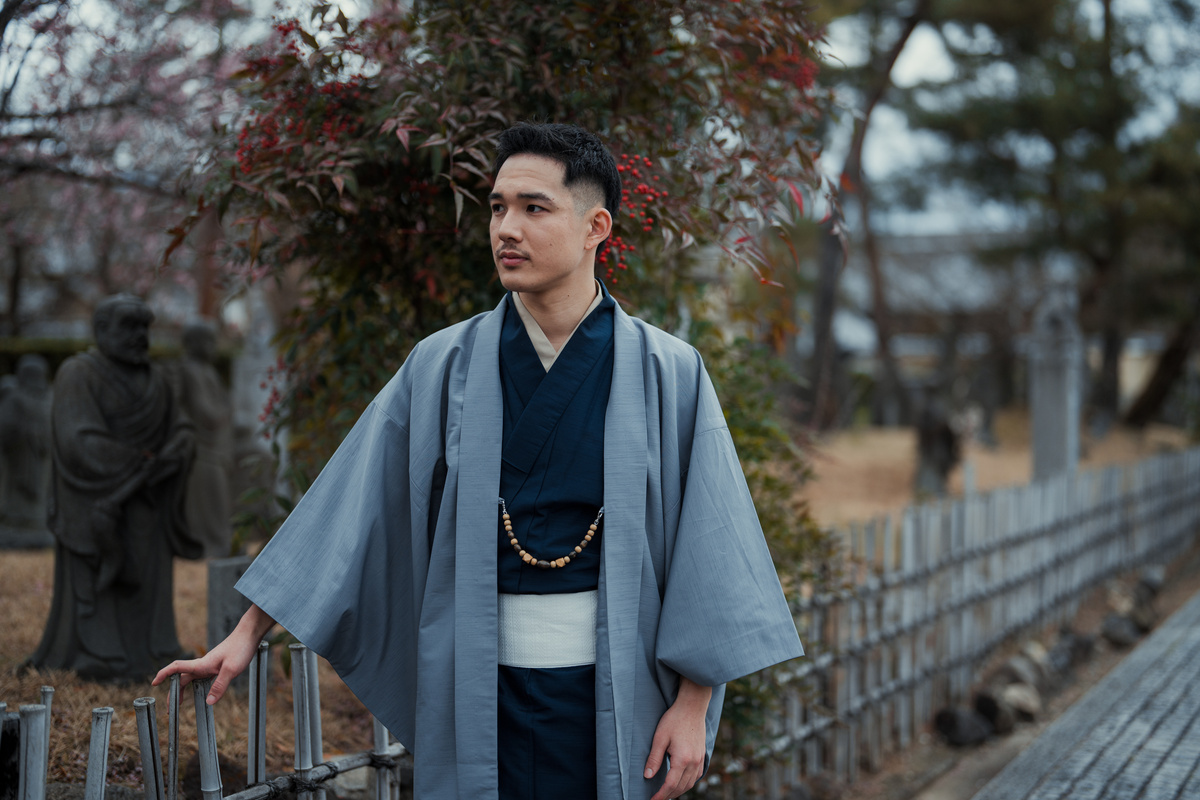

left=655, top=366, right=804, bottom=686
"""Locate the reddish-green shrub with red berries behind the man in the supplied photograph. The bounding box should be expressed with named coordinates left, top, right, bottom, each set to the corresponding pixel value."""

left=175, top=0, right=828, bottom=777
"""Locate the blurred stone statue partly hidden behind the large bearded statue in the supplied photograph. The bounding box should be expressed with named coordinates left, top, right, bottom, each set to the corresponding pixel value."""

left=179, top=324, right=233, bottom=558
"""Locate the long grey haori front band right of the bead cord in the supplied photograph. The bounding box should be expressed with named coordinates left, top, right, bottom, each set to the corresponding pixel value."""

left=596, top=305, right=648, bottom=796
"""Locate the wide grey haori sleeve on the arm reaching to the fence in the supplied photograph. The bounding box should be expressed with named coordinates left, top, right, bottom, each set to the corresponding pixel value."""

left=236, top=350, right=440, bottom=746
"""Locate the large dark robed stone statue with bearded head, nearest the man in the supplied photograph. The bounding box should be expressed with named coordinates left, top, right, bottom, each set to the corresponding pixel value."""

left=30, top=295, right=203, bottom=680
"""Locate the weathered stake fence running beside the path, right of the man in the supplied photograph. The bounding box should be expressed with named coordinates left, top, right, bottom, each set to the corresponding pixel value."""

left=703, top=449, right=1200, bottom=799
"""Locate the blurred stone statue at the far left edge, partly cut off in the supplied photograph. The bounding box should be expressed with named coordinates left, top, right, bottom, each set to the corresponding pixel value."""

left=0, top=355, right=53, bottom=547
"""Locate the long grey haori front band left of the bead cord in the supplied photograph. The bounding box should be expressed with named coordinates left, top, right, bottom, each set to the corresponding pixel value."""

left=454, top=302, right=504, bottom=798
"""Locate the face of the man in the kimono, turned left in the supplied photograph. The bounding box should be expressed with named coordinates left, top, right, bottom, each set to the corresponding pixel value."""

left=490, top=154, right=612, bottom=294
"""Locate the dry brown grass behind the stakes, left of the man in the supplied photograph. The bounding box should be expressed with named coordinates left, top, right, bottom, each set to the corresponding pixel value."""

left=0, top=551, right=372, bottom=788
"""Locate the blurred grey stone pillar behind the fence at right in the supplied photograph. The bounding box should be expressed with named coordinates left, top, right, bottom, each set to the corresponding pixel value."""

left=1030, top=287, right=1084, bottom=481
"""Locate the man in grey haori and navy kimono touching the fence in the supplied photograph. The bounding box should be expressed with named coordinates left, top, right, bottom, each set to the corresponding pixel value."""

left=156, top=125, right=802, bottom=800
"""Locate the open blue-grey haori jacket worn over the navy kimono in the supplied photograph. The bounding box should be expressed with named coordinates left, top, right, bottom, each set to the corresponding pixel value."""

left=238, top=302, right=803, bottom=800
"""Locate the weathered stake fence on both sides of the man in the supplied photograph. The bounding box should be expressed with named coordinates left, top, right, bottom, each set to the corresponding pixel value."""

left=9, top=449, right=1200, bottom=800
